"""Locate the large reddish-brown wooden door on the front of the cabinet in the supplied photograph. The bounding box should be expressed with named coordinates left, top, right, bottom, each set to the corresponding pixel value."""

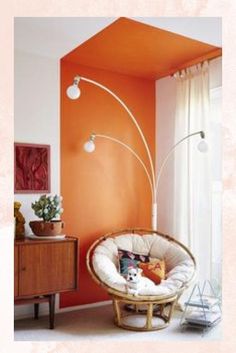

left=19, top=241, right=77, bottom=296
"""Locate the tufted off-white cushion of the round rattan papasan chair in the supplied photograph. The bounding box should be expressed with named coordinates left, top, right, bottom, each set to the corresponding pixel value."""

left=92, top=234, right=194, bottom=295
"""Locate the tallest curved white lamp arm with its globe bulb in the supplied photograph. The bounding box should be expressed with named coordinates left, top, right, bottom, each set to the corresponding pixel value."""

left=67, top=75, right=156, bottom=195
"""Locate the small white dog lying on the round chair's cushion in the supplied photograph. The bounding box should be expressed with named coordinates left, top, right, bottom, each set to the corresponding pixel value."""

left=126, top=267, right=155, bottom=296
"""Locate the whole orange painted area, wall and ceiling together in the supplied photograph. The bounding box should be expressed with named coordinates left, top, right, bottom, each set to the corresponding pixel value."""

left=61, top=18, right=221, bottom=306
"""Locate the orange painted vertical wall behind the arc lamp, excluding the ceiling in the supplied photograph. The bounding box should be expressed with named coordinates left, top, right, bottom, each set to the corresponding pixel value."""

left=60, top=60, right=155, bottom=307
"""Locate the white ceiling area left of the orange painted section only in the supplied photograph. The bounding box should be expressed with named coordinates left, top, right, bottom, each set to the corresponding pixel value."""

left=14, top=17, right=115, bottom=59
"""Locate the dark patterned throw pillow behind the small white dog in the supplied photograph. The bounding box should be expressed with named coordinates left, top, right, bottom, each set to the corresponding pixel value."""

left=118, top=249, right=150, bottom=276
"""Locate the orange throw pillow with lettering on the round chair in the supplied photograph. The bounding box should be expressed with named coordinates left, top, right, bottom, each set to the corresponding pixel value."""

left=138, top=259, right=166, bottom=284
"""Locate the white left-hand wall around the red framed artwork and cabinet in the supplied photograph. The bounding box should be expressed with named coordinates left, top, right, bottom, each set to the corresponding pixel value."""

left=14, top=50, right=60, bottom=318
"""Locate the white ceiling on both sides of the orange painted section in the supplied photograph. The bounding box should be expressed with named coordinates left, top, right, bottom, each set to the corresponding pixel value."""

left=14, top=17, right=222, bottom=59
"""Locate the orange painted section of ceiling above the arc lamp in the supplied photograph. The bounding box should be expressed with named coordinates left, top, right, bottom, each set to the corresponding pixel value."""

left=63, top=18, right=221, bottom=79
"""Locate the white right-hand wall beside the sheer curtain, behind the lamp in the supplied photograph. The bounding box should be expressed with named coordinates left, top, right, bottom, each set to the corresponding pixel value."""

left=156, top=58, right=222, bottom=234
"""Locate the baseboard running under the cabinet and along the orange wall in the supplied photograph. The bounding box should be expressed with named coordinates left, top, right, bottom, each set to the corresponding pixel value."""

left=14, top=295, right=112, bottom=320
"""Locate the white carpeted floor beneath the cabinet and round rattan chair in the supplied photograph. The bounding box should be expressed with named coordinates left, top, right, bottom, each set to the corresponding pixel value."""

left=15, top=305, right=222, bottom=341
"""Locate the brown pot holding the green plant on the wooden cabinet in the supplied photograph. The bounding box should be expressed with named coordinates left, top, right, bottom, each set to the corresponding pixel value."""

left=29, top=220, right=64, bottom=236
